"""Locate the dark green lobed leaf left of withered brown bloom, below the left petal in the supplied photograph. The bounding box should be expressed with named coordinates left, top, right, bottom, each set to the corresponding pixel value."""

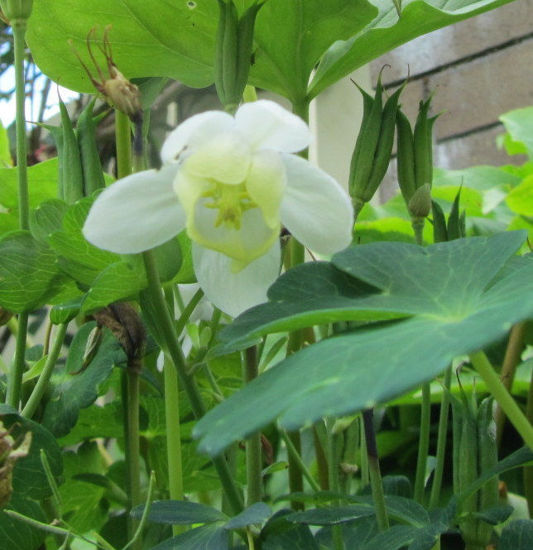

left=43, top=322, right=125, bottom=437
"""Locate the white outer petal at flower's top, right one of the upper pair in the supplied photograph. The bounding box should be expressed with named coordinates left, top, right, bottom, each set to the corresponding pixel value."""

left=235, top=99, right=311, bottom=153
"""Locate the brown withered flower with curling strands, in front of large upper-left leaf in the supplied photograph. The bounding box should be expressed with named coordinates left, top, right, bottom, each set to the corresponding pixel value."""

left=70, top=25, right=142, bottom=122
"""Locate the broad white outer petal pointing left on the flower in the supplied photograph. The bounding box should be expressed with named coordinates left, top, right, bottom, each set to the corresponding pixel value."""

left=83, top=165, right=185, bottom=254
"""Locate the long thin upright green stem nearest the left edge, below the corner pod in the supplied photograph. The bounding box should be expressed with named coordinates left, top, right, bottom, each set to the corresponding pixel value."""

left=6, top=19, right=30, bottom=409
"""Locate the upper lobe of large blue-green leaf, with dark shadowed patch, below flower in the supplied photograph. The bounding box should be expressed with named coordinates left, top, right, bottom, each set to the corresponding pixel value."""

left=220, top=231, right=524, bottom=351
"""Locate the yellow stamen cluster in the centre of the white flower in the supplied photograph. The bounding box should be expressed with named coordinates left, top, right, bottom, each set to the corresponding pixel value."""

left=201, top=180, right=257, bottom=230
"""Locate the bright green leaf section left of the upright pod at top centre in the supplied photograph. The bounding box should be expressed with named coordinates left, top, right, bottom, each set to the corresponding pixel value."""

left=27, top=0, right=218, bottom=93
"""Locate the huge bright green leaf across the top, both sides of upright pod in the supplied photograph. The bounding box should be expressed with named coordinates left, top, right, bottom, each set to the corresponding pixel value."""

left=28, top=0, right=377, bottom=101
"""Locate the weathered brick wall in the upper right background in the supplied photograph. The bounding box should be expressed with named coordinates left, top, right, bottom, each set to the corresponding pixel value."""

left=371, top=0, right=533, bottom=198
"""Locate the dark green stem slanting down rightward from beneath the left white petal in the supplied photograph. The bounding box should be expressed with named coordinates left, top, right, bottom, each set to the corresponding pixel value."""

left=143, top=251, right=243, bottom=514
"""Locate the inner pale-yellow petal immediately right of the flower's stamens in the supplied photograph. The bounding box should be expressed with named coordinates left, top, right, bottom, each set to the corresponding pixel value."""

left=246, top=151, right=286, bottom=227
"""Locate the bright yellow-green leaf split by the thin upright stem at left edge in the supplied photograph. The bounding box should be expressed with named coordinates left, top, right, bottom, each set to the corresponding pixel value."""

left=0, top=158, right=57, bottom=235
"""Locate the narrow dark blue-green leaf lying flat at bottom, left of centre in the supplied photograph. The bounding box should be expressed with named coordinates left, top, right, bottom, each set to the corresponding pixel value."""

left=131, top=500, right=228, bottom=525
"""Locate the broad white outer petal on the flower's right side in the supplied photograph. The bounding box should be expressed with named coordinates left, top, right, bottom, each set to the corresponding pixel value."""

left=281, top=155, right=353, bottom=255
